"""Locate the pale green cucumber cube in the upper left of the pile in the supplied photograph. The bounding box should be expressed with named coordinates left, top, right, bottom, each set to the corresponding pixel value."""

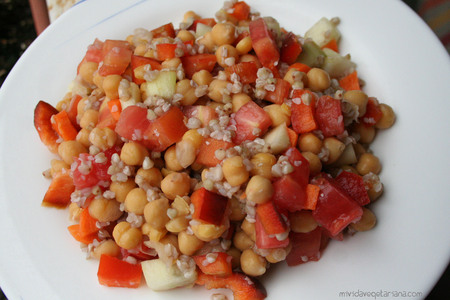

left=141, top=71, right=177, bottom=99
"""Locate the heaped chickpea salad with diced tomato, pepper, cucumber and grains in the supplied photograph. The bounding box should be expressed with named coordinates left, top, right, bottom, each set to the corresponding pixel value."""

left=34, top=1, right=395, bottom=299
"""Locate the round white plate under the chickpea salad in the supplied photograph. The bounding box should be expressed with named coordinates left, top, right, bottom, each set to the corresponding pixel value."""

left=0, top=0, right=450, bottom=300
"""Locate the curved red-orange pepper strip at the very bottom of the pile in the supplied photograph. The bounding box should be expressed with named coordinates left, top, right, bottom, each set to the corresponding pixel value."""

left=195, top=271, right=267, bottom=300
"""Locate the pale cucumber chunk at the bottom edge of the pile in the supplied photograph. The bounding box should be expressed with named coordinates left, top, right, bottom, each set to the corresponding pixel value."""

left=141, top=258, right=197, bottom=291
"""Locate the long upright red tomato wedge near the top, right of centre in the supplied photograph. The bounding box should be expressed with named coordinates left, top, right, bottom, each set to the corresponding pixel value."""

left=249, top=18, right=280, bottom=70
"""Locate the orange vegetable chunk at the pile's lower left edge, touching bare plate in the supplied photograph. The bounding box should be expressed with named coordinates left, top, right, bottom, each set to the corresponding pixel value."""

left=42, top=171, right=75, bottom=208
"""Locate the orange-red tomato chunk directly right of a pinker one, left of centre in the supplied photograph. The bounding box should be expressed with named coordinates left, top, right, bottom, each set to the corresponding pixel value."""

left=143, top=106, right=188, bottom=152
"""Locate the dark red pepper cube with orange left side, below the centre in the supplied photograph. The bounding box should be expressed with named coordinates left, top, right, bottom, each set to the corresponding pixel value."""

left=191, top=187, right=228, bottom=225
